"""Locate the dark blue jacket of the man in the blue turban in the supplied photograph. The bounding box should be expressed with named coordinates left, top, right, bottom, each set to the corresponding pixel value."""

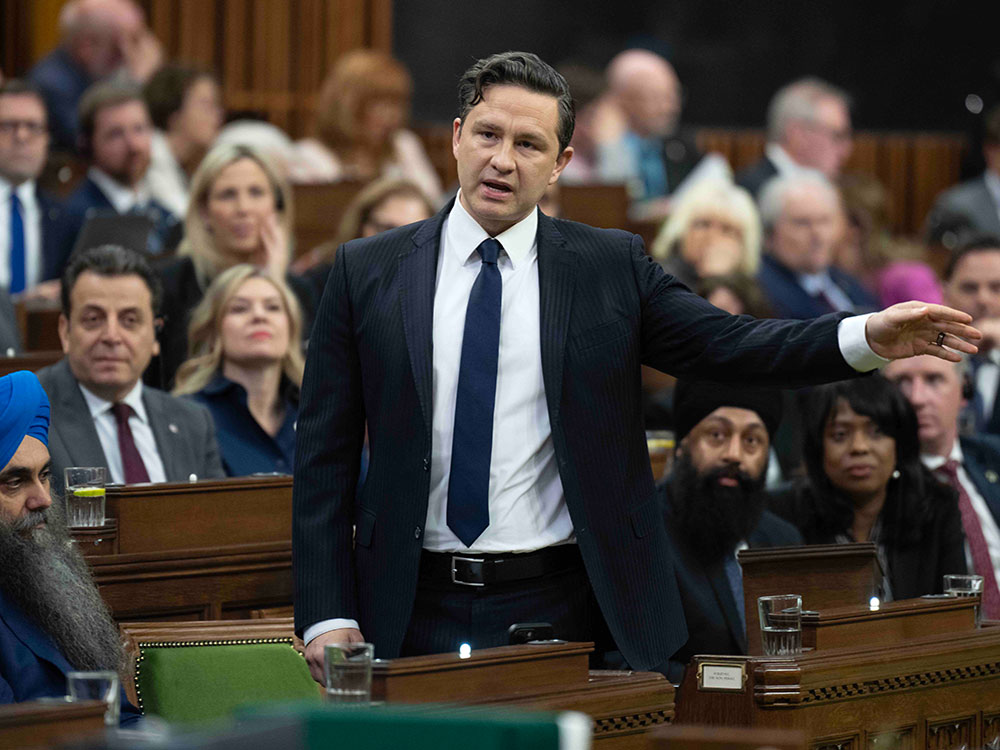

left=0, top=590, right=142, bottom=727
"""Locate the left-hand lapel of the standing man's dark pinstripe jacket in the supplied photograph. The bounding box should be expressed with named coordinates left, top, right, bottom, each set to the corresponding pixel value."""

left=396, top=207, right=446, bottom=436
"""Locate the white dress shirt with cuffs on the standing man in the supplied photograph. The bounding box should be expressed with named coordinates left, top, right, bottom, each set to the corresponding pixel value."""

left=303, top=196, right=888, bottom=643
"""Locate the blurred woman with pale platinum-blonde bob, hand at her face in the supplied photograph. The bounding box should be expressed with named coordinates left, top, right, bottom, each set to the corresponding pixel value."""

left=651, top=179, right=761, bottom=288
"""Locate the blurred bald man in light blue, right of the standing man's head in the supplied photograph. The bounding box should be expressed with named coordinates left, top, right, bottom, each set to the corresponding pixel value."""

left=594, top=49, right=701, bottom=214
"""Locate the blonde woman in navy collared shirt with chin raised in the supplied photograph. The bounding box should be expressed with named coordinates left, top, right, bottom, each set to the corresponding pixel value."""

left=174, top=264, right=304, bottom=477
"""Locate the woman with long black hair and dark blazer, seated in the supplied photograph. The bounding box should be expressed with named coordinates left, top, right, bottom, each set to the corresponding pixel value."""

left=772, top=375, right=966, bottom=600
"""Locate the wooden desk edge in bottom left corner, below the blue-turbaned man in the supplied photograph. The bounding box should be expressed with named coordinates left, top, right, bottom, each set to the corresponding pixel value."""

left=0, top=701, right=106, bottom=748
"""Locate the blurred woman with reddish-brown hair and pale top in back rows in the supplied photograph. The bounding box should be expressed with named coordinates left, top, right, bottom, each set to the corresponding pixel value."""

left=298, top=49, right=441, bottom=202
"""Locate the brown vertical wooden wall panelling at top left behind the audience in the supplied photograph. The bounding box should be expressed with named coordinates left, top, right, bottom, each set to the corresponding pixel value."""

left=6, top=0, right=392, bottom=138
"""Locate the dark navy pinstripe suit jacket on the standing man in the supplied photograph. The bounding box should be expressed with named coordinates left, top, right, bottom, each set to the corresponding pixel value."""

left=293, top=200, right=853, bottom=669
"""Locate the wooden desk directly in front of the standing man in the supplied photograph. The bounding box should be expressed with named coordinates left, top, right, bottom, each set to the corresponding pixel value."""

left=372, top=643, right=674, bottom=750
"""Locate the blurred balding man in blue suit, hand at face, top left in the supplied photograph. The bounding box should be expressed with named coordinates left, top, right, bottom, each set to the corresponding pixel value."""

left=28, top=0, right=163, bottom=151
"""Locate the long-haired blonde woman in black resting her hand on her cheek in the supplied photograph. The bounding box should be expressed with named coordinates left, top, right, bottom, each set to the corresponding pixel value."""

left=152, top=143, right=313, bottom=387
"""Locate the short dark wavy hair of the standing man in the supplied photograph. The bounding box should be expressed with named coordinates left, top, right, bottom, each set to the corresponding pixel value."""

left=458, top=52, right=576, bottom=153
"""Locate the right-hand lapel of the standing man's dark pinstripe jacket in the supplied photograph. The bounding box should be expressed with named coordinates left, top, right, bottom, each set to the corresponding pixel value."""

left=538, top=212, right=577, bottom=427
